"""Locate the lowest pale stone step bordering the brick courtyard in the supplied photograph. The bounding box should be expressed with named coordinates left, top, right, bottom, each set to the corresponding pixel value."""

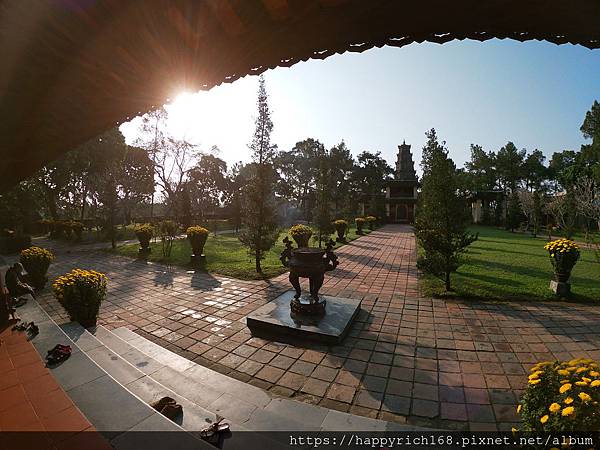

left=109, top=327, right=423, bottom=431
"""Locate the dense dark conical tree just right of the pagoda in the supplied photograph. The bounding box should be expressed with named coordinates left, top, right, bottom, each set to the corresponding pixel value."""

left=415, top=129, right=477, bottom=291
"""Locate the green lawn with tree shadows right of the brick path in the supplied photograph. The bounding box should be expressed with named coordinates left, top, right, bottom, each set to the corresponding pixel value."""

left=420, top=226, right=600, bottom=302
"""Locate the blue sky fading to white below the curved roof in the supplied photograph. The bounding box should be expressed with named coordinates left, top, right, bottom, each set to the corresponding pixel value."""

left=121, top=40, right=600, bottom=174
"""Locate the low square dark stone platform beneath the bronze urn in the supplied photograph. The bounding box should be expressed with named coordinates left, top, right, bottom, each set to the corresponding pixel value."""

left=246, top=291, right=360, bottom=344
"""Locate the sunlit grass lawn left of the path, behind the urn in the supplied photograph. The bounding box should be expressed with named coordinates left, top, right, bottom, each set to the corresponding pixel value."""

left=116, top=227, right=369, bottom=280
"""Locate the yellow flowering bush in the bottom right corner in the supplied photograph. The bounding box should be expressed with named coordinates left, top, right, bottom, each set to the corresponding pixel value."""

left=513, top=358, right=600, bottom=434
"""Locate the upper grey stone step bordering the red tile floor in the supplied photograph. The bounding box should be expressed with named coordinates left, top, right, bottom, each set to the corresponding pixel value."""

left=17, top=299, right=213, bottom=450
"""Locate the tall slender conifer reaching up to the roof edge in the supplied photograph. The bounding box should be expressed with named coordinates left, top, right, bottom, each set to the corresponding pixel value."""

left=239, top=75, right=278, bottom=273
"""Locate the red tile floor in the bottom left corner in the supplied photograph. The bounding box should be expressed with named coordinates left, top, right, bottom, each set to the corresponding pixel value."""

left=0, top=324, right=111, bottom=450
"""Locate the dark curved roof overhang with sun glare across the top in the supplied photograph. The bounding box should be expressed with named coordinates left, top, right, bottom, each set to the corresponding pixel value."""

left=0, top=0, right=600, bottom=189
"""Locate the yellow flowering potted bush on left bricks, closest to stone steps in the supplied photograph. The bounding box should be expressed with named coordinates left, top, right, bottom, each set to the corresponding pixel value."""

left=52, top=269, right=108, bottom=328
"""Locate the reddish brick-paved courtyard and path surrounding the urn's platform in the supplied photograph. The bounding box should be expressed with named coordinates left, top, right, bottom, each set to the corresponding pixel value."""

left=31, top=225, right=600, bottom=430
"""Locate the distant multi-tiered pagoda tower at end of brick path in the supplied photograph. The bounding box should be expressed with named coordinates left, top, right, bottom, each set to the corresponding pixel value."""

left=385, top=142, right=419, bottom=223
